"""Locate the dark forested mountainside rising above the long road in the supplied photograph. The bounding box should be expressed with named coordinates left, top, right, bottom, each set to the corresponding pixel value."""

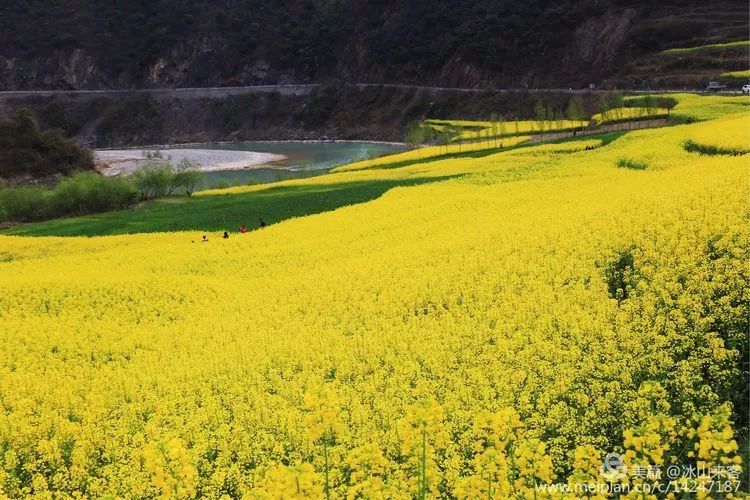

left=0, top=0, right=748, bottom=89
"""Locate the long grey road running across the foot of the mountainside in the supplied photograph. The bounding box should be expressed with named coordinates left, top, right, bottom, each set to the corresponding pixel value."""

left=0, top=83, right=742, bottom=100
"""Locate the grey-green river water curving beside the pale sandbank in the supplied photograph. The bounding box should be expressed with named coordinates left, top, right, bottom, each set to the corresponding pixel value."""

left=178, top=142, right=405, bottom=189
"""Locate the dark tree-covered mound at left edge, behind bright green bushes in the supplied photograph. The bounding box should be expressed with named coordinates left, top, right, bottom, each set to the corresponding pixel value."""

left=0, top=108, right=93, bottom=177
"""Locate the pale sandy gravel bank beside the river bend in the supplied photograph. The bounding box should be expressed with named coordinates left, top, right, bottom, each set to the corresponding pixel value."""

left=94, top=149, right=286, bottom=175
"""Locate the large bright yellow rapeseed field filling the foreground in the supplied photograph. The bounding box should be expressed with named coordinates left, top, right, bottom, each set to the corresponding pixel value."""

left=0, top=96, right=750, bottom=499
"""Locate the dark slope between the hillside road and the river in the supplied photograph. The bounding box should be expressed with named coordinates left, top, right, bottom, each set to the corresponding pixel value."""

left=0, top=85, right=600, bottom=147
